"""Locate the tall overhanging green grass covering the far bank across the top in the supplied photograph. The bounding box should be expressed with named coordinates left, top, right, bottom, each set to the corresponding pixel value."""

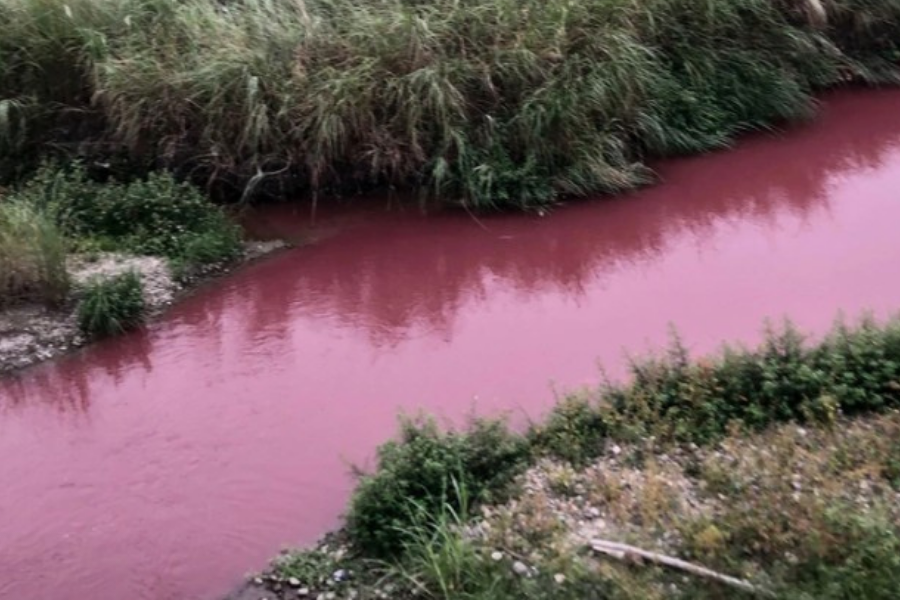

left=0, top=0, right=900, bottom=208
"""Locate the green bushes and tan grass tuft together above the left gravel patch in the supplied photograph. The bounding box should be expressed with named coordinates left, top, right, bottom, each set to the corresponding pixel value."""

left=0, top=164, right=241, bottom=305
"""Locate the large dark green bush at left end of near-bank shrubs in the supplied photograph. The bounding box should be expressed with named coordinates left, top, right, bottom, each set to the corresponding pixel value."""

left=347, top=419, right=528, bottom=556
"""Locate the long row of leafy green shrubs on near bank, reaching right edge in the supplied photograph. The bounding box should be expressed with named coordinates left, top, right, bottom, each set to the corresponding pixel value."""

left=598, top=319, right=900, bottom=443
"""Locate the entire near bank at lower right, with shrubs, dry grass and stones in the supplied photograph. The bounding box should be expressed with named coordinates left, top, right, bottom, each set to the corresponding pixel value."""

left=241, top=319, right=900, bottom=600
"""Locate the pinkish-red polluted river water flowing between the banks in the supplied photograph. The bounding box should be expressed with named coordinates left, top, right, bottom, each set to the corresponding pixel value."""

left=0, top=91, right=900, bottom=600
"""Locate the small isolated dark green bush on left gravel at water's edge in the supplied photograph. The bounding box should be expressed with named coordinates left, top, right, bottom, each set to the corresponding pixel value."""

left=78, top=271, right=145, bottom=337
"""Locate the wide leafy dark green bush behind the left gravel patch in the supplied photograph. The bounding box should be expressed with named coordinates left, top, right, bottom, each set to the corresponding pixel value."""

left=17, top=165, right=241, bottom=265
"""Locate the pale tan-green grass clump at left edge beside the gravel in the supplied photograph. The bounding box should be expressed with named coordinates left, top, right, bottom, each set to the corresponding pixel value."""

left=0, top=198, right=69, bottom=305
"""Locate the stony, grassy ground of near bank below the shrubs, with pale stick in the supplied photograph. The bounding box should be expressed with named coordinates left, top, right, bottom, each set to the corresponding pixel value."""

left=241, top=412, right=900, bottom=600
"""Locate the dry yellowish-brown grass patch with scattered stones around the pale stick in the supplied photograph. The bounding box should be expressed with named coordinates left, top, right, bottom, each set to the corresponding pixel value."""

left=470, top=412, right=900, bottom=600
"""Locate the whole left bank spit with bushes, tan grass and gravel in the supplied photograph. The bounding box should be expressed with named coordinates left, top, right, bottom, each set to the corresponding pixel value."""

left=0, top=165, right=283, bottom=374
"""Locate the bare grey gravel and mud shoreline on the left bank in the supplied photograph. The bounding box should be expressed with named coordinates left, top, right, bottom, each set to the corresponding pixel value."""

left=0, top=240, right=287, bottom=377
